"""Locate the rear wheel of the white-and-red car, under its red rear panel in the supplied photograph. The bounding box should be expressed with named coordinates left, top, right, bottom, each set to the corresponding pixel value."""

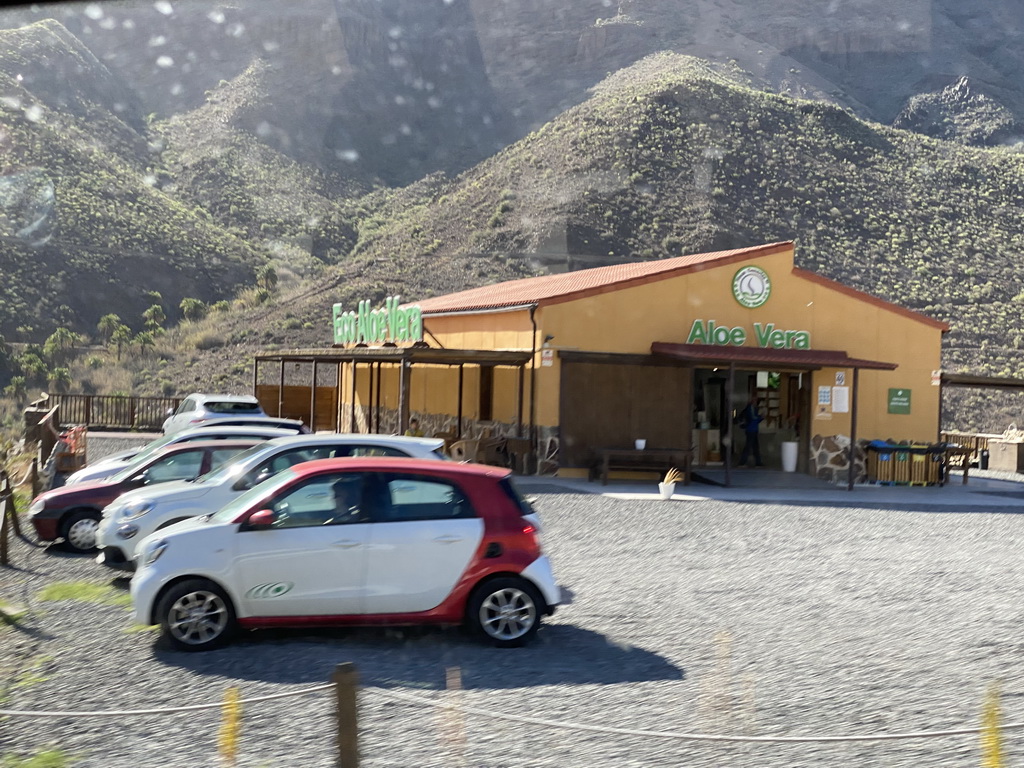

left=466, top=577, right=544, bottom=648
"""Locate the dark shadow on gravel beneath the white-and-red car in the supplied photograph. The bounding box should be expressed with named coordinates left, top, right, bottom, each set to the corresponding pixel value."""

left=154, top=625, right=685, bottom=689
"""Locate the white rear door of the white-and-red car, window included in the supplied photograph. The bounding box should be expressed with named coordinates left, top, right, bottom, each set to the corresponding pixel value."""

left=366, top=473, right=483, bottom=613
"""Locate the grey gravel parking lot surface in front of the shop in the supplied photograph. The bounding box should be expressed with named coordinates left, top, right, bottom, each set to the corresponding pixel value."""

left=0, top=494, right=1024, bottom=768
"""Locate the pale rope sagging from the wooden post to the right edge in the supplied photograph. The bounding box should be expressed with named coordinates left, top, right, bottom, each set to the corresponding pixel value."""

left=379, top=689, right=1024, bottom=743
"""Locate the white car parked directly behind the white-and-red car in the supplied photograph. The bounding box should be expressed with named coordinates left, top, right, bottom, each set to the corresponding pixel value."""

left=96, top=430, right=447, bottom=568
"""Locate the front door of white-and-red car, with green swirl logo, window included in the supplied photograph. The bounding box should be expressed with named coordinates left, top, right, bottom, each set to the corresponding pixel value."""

left=233, top=472, right=371, bottom=616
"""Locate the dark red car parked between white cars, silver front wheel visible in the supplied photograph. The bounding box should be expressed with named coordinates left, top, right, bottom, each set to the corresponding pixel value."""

left=29, top=439, right=260, bottom=552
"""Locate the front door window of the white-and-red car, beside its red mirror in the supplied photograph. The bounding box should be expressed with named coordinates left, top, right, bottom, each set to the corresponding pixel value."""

left=270, top=472, right=369, bottom=528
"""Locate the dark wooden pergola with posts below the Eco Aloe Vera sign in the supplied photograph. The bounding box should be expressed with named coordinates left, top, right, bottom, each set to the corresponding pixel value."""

left=253, top=344, right=532, bottom=437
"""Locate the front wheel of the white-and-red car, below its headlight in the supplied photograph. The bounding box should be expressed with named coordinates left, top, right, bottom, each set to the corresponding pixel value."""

left=157, top=579, right=237, bottom=651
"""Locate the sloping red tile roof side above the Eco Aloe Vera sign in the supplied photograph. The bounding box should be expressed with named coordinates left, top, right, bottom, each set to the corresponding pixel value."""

left=416, top=241, right=793, bottom=315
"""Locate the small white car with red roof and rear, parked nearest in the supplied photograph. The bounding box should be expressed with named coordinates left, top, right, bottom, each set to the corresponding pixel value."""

left=131, top=459, right=562, bottom=650
